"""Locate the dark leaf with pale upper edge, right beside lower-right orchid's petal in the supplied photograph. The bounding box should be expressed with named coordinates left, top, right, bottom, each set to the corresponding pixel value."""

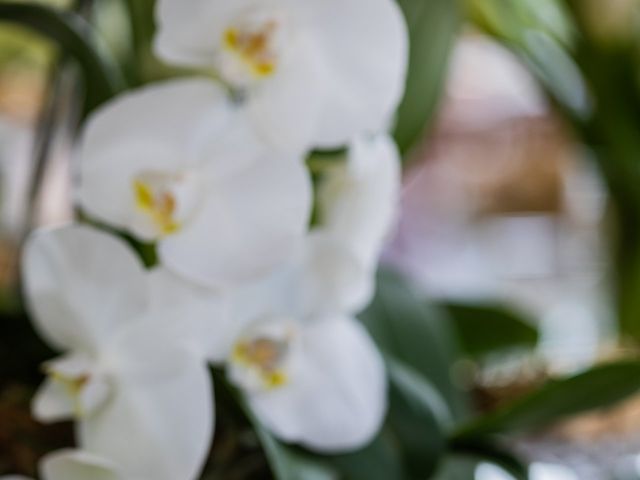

left=388, top=360, right=452, bottom=478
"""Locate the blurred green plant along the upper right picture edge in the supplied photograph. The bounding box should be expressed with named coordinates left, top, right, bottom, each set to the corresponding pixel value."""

left=468, top=0, right=640, bottom=342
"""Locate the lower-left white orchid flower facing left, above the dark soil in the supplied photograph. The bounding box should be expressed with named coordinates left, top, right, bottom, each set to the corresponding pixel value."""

left=23, top=226, right=215, bottom=480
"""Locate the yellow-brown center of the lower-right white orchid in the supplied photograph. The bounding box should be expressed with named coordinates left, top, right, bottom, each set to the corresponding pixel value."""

left=233, top=337, right=288, bottom=390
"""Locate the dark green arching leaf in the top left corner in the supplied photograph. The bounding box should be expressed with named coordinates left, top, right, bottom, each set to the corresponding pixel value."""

left=0, top=2, right=124, bottom=111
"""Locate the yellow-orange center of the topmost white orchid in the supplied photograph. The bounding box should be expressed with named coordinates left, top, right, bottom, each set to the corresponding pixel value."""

left=223, top=21, right=278, bottom=78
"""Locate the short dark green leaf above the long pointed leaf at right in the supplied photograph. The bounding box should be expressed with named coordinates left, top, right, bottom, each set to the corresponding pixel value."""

left=442, top=302, right=538, bottom=358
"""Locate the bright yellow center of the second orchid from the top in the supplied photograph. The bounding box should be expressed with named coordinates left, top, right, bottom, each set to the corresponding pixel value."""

left=133, top=179, right=180, bottom=235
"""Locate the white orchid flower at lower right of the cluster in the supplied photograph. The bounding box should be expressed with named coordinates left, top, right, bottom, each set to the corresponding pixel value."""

left=213, top=234, right=386, bottom=452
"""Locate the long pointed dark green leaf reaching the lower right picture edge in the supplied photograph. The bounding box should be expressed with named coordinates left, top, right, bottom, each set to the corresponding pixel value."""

left=454, top=361, right=640, bottom=441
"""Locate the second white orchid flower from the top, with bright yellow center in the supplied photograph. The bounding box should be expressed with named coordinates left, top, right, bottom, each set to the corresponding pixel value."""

left=79, top=80, right=311, bottom=287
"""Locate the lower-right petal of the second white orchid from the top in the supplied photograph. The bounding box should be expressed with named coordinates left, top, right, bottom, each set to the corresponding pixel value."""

left=159, top=152, right=311, bottom=287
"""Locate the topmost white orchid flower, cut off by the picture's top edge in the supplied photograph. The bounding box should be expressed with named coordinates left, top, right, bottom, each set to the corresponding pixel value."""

left=155, top=0, right=408, bottom=152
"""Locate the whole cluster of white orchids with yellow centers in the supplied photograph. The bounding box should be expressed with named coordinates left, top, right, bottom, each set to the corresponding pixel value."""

left=16, top=0, right=408, bottom=480
